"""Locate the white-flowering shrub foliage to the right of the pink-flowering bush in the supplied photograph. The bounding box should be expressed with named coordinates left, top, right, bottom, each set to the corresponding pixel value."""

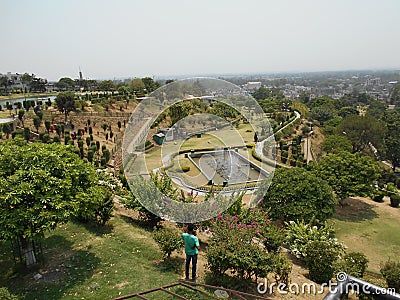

left=285, top=221, right=346, bottom=260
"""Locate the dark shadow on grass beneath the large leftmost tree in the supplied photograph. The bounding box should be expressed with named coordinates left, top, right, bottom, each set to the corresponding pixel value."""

left=0, top=235, right=100, bottom=299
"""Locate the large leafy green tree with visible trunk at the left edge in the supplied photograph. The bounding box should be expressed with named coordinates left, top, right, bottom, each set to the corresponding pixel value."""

left=0, top=139, right=96, bottom=265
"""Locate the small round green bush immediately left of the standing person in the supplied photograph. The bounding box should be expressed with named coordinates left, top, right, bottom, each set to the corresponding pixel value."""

left=153, top=228, right=183, bottom=258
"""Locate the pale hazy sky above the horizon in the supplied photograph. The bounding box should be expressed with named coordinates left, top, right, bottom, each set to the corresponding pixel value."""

left=0, top=0, right=400, bottom=80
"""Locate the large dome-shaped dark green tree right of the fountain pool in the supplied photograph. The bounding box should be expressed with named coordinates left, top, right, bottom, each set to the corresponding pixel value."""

left=257, top=168, right=336, bottom=222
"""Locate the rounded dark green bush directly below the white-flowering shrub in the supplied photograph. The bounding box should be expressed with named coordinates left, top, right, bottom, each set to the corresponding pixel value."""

left=305, top=240, right=340, bottom=283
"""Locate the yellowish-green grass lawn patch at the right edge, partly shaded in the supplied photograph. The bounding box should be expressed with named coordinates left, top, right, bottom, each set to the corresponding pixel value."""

left=333, top=198, right=400, bottom=273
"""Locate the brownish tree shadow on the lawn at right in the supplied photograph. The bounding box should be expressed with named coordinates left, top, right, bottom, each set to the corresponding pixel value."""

left=333, top=198, right=378, bottom=222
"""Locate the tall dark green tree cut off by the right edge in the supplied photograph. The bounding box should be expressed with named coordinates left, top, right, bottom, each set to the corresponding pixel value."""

left=384, top=111, right=400, bottom=172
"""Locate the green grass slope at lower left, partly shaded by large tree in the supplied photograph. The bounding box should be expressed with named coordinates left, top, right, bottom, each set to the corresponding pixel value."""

left=0, top=215, right=183, bottom=299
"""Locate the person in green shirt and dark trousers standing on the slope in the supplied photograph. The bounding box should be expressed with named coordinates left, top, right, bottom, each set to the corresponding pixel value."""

left=182, top=224, right=200, bottom=282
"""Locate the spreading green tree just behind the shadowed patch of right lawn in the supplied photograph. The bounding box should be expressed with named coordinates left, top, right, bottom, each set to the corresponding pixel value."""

left=315, top=151, right=379, bottom=204
